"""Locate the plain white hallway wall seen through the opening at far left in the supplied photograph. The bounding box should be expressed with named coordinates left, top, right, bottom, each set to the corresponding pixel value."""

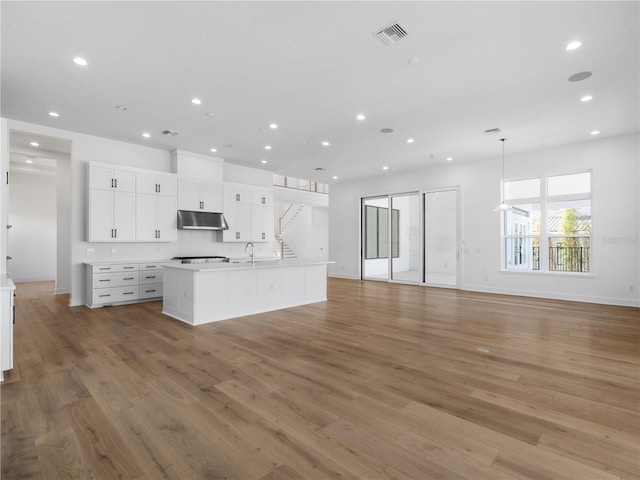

left=7, top=172, right=57, bottom=282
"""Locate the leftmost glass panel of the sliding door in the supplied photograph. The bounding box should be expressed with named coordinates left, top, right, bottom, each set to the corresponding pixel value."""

left=362, top=197, right=389, bottom=281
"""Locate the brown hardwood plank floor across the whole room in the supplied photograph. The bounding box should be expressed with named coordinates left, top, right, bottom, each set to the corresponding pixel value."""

left=1, top=279, right=640, bottom=480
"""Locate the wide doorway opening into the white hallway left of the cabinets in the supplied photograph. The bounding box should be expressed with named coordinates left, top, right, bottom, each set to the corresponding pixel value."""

left=7, top=130, right=71, bottom=294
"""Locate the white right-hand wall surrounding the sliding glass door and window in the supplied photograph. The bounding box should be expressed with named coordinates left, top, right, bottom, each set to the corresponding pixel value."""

left=329, top=133, right=640, bottom=306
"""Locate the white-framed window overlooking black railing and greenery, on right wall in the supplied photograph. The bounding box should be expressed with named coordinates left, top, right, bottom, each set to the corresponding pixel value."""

left=503, top=172, right=591, bottom=272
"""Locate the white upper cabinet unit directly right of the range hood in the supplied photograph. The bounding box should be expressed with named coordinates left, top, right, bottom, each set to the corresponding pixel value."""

left=222, top=183, right=274, bottom=242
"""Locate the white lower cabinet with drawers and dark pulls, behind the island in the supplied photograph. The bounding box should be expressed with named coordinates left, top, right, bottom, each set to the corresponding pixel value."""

left=85, top=262, right=170, bottom=308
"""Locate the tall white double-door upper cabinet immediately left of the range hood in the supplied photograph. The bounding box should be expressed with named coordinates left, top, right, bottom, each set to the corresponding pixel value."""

left=136, top=194, right=178, bottom=242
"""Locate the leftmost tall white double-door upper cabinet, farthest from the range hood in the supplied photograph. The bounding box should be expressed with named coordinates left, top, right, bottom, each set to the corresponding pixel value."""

left=87, top=188, right=136, bottom=242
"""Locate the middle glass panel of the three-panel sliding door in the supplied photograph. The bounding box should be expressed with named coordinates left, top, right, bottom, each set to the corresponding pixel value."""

left=391, top=193, right=422, bottom=283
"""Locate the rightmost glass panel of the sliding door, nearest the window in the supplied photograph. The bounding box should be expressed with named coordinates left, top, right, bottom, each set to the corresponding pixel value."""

left=424, top=190, right=458, bottom=286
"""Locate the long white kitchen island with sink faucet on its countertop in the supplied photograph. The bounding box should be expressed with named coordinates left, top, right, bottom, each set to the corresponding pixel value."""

left=162, top=259, right=330, bottom=325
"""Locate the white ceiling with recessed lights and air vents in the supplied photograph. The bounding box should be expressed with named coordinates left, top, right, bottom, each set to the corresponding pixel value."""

left=0, top=0, right=640, bottom=183
